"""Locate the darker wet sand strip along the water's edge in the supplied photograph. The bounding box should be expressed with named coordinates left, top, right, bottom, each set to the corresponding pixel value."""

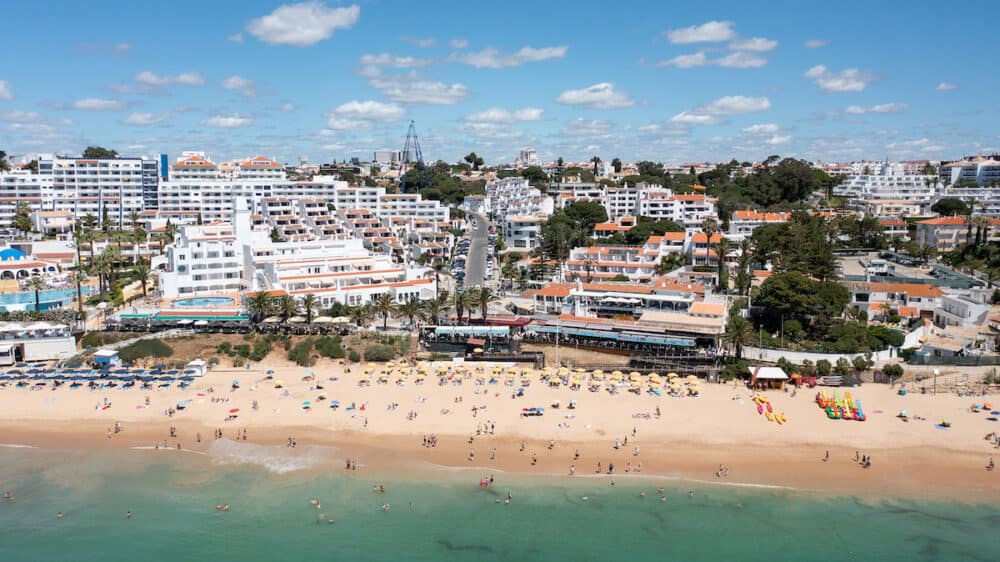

left=0, top=416, right=1000, bottom=505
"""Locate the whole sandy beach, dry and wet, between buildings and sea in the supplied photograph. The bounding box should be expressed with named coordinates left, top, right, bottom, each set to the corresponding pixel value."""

left=0, top=361, right=1000, bottom=501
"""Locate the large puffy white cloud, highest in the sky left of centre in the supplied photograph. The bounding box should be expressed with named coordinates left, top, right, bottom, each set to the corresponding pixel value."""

left=247, top=0, right=361, bottom=47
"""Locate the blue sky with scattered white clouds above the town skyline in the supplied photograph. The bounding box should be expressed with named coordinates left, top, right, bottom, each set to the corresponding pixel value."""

left=0, top=0, right=1000, bottom=163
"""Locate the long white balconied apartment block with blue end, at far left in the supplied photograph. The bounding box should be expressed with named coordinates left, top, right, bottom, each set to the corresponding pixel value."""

left=0, top=155, right=157, bottom=228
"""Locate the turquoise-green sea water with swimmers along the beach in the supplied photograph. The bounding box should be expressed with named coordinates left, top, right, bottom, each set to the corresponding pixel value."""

left=0, top=446, right=1000, bottom=562
